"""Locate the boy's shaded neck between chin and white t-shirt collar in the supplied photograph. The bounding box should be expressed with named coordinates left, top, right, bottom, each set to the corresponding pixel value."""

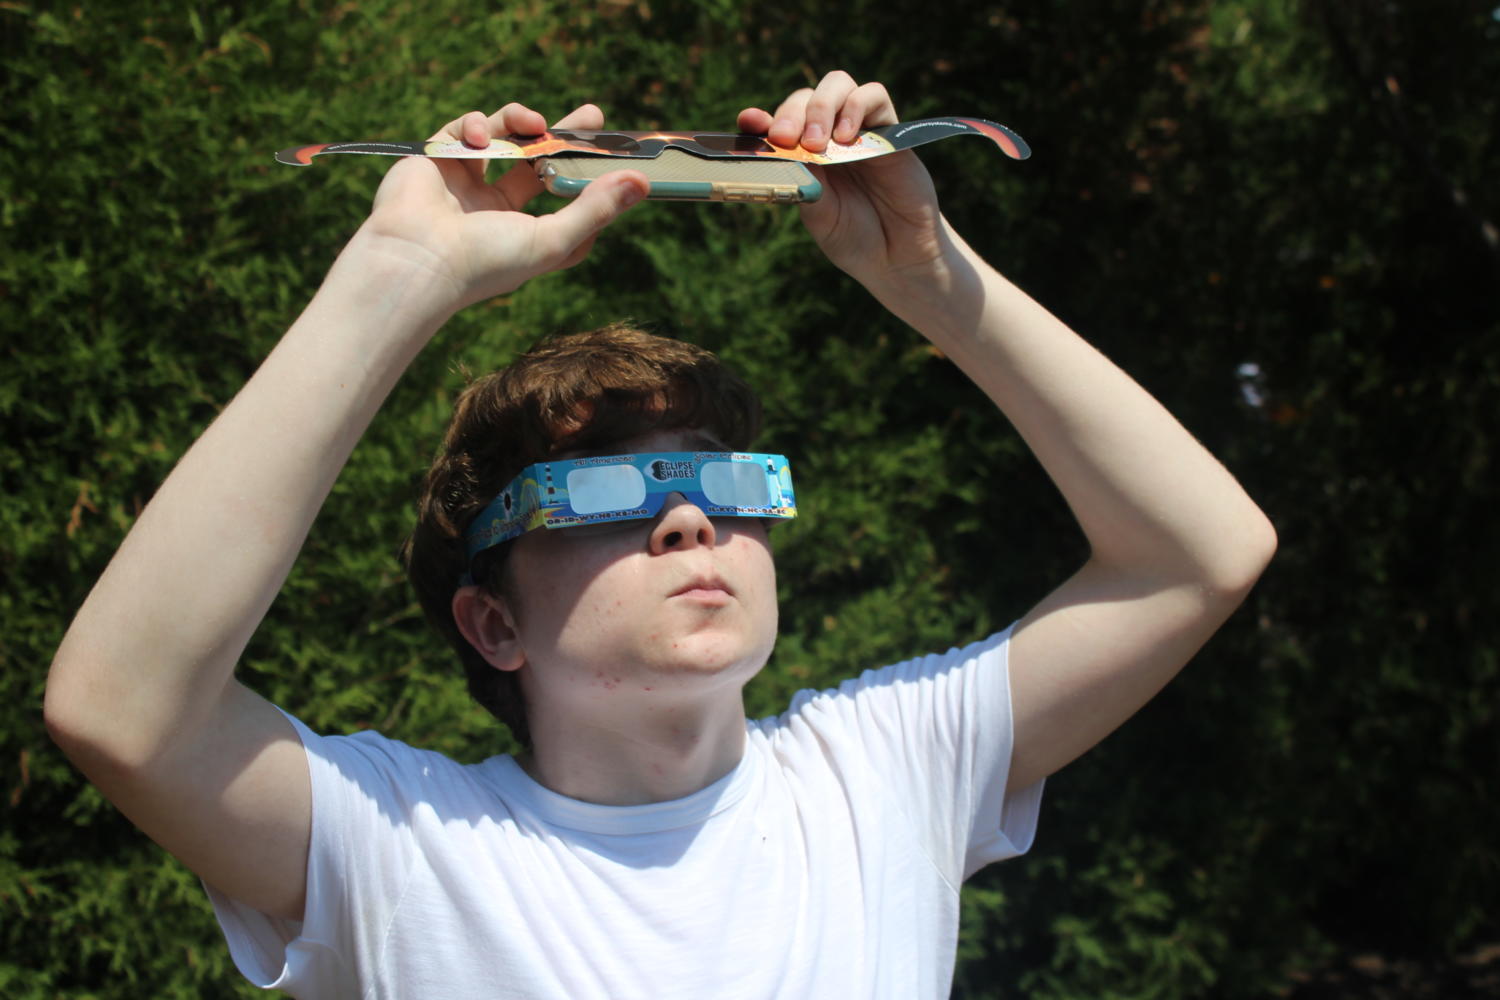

left=516, top=691, right=746, bottom=805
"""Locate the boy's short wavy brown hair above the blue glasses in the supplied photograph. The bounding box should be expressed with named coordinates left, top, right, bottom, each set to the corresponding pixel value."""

left=402, top=324, right=761, bottom=745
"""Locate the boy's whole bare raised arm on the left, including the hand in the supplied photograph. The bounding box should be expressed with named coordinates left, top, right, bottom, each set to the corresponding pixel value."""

left=47, top=105, right=645, bottom=919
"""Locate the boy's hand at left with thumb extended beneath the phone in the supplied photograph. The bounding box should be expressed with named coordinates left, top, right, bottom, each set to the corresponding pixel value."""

left=357, top=103, right=648, bottom=310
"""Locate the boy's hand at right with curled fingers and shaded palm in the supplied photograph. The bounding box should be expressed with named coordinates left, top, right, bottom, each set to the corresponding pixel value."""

left=738, top=70, right=945, bottom=291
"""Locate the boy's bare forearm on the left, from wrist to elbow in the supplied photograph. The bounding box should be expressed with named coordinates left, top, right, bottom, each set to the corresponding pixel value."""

left=48, top=232, right=447, bottom=757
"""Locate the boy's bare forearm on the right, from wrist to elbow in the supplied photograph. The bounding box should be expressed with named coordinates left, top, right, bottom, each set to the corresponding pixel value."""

left=872, top=228, right=1274, bottom=592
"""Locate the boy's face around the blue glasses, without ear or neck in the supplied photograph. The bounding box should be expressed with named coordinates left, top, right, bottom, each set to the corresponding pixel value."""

left=504, top=430, right=777, bottom=709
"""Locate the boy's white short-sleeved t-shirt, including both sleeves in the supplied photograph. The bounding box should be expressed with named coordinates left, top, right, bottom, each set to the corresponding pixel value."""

left=210, top=633, right=1041, bottom=1000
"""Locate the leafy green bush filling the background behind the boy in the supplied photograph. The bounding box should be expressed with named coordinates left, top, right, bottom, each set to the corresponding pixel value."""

left=0, top=0, right=1500, bottom=1000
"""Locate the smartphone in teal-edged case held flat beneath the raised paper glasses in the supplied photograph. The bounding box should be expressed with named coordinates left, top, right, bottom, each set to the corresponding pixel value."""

left=537, top=147, right=824, bottom=205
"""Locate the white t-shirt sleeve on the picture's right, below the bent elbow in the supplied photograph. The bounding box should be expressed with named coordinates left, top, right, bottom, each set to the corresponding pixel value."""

left=783, top=628, right=1043, bottom=886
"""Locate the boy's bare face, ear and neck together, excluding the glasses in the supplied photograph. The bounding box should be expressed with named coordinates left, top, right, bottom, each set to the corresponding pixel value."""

left=455, top=430, right=777, bottom=805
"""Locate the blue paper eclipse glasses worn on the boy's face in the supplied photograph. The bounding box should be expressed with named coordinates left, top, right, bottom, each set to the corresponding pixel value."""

left=467, top=451, right=797, bottom=561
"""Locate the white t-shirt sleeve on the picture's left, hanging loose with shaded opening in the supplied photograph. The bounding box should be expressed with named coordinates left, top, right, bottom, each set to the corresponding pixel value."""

left=204, top=715, right=423, bottom=997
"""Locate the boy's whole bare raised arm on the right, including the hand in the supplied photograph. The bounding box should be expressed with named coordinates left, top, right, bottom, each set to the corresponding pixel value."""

left=740, top=72, right=1275, bottom=789
